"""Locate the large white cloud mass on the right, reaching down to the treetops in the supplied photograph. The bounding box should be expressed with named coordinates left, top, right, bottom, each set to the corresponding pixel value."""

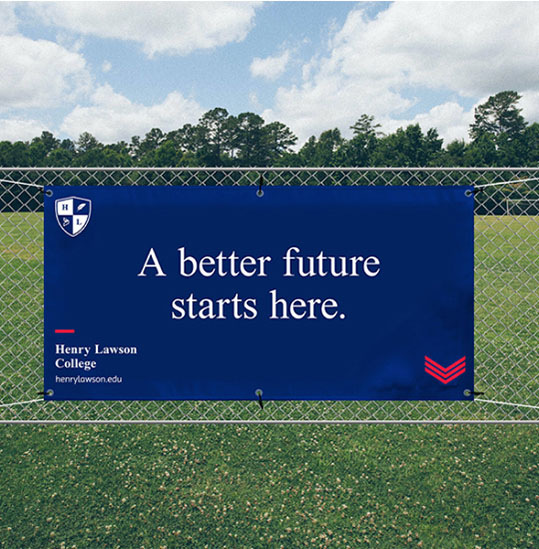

left=263, top=2, right=539, bottom=146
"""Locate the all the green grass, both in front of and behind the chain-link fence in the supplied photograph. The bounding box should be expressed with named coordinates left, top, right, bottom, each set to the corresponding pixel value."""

left=0, top=214, right=539, bottom=548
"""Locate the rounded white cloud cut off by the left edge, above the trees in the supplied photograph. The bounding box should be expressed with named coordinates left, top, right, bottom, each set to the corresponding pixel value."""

left=0, top=35, right=90, bottom=111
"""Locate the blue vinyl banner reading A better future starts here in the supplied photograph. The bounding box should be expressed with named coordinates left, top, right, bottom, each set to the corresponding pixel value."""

left=44, top=186, right=474, bottom=400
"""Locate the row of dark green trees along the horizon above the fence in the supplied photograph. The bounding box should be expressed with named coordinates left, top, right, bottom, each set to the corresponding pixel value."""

left=0, top=91, right=539, bottom=167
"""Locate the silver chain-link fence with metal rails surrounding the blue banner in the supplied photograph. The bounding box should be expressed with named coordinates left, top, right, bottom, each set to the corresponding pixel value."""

left=0, top=168, right=539, bottom=423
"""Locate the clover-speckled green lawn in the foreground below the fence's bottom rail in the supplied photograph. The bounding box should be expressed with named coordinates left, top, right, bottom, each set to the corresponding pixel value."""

left=0, top=425, right=539, bottom=548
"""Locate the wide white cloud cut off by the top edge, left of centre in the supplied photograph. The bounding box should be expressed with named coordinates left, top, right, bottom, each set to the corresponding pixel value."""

left=33, top=2, right=261, bottom=56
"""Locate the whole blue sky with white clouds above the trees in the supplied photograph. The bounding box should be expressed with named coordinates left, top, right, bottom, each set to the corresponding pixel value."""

left=0, top=1, right=539, bottom=145
